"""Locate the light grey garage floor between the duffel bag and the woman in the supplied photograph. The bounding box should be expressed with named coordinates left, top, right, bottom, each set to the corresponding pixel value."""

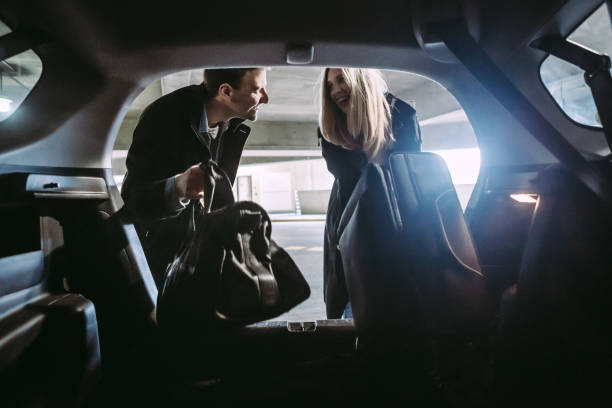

left=272, top=220, right=326, bottom=321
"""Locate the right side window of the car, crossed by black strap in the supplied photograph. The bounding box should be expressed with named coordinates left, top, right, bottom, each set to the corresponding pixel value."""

left=540, top=3, right=612, bottom=127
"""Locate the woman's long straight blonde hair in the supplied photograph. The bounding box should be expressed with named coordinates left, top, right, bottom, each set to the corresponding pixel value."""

left=319, top=68, right=395, bottom=163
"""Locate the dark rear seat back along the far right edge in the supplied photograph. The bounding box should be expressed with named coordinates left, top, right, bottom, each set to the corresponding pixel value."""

left=497, top=162, right=612, bottom=405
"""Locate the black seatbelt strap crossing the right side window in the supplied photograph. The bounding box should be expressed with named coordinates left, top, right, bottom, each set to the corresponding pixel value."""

left=530, top=35, right=612, bottom=150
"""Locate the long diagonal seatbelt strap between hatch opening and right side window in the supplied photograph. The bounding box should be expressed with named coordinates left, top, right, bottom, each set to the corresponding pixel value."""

left=431, top=20, right=612, bottom=206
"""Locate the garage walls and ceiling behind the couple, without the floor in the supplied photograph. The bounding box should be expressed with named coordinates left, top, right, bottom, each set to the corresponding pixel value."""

left=112, top=67, right=480, bottom=207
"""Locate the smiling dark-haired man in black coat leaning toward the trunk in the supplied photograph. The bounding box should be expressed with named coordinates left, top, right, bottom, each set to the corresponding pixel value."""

left=121, top=68, right=268, bottom=289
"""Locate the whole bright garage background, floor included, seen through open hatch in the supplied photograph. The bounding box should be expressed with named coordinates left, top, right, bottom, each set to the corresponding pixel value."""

left=112, top=67, right=480, bottom=321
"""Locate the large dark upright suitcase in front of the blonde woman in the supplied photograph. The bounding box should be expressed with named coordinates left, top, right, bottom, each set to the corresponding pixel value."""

left=338, top=153, right=490, bottom=343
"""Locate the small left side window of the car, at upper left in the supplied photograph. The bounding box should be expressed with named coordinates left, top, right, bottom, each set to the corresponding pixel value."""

left=0, top=21, right=42, bottom=122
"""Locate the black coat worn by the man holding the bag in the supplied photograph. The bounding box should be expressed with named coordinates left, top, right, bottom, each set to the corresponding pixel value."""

left=121, top=85, right=250, bottom=288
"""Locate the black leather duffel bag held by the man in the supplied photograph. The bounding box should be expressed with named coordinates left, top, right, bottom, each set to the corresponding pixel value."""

left=157, top=161, right=310, bottom=330
